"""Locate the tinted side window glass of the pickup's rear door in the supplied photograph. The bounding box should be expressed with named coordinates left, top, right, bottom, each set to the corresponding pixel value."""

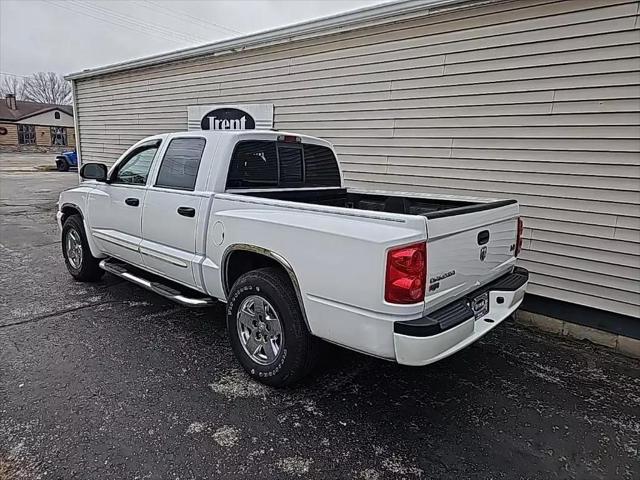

left=156, top=138, right=205, bottom=190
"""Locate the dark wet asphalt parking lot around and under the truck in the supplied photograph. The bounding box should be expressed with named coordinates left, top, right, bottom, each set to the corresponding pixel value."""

left=0, top=163, right=640, bottom=480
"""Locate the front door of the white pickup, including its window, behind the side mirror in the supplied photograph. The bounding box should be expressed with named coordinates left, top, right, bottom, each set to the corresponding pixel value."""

left=88, top=140, right=160, bottom=265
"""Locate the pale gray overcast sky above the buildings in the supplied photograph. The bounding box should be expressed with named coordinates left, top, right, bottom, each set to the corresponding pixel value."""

left=0, top=0, right=389, bottom=79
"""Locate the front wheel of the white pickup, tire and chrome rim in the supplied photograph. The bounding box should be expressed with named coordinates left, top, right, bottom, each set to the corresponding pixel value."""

left=62, top=215, right=104, bottom=282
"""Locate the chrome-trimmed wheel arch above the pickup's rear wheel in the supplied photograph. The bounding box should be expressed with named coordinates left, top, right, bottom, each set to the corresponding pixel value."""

left=220, top=243, right=311, bottom=332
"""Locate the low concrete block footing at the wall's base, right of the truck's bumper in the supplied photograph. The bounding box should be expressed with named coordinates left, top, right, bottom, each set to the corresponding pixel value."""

left=515, top=310, right=640, bottom=359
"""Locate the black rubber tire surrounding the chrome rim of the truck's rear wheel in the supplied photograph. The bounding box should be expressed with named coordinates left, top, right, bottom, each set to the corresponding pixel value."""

left=227, top=268, right=320, bottom=387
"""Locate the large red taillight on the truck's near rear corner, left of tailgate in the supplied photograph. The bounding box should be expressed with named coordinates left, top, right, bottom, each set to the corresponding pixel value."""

left=384, top=242, right=427, bottom=303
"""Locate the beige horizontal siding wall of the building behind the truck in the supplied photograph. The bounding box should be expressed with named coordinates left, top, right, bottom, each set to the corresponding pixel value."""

left=72, top=0, right=640, bottom=317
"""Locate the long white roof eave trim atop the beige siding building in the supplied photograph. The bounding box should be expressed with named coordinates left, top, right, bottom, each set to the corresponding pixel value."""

left=65, top=0, right=484, bottom=81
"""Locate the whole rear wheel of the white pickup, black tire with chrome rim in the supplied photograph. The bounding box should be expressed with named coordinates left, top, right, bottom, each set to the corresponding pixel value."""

left=227, top=267, right=319, bottom=387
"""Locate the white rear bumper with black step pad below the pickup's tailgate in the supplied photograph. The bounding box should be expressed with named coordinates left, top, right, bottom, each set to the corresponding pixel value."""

left=393, top=268, right=529, bottom=365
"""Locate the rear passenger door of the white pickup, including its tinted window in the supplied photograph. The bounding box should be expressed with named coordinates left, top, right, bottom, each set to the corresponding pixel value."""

left=140, top=137, right=207, bottom=288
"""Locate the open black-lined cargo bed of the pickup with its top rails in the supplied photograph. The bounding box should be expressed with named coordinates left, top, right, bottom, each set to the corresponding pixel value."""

left=234, top=188, right=516, bottom=218
